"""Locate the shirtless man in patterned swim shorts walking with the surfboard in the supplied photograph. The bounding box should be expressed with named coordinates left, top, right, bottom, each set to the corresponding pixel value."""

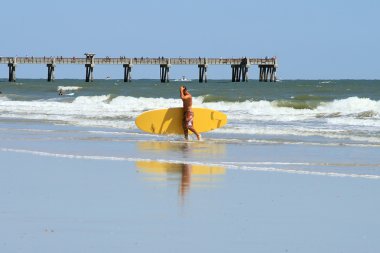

left=179, top=86, right=201, bottom=140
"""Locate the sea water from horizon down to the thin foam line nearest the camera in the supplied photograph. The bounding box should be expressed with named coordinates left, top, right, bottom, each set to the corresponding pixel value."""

left=0, top=79, right=380, bottom=178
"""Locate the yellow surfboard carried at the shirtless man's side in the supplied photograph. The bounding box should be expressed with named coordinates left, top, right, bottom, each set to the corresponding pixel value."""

left=135, top=107, right=227, bottom=134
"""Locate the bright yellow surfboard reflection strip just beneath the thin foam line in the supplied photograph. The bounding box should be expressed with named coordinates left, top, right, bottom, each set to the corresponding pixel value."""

left=136, top=161, right=225, bottom=175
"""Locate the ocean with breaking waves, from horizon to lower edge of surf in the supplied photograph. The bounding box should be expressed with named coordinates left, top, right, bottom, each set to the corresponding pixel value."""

left=0, top=80, right=380, bottom=146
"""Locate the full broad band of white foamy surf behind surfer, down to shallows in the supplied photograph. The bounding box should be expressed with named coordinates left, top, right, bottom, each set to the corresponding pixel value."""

left=0, top=95, right=380, bottom=143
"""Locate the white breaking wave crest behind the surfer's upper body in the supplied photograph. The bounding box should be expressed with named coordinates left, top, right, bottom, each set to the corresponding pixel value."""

left=0, top=95, right=380, bottom=119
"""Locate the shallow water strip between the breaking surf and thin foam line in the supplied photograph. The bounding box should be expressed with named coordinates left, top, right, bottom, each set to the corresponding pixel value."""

left=0, top=117, right=380, bottom=179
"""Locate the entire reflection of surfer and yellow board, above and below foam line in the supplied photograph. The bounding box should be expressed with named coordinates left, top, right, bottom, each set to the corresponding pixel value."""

left=136, top=141, right=225, bottom=204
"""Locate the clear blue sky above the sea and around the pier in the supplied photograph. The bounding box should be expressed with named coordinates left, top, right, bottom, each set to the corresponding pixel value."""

left=0, top=0, right=380, bottom=79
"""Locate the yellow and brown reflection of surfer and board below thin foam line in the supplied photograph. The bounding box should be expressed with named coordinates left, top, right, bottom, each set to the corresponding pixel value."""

left=136, top=161, right=225, bottom=202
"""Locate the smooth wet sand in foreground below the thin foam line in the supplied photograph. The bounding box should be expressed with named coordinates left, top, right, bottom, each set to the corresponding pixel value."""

left=0, top=152, right=380, bottom=252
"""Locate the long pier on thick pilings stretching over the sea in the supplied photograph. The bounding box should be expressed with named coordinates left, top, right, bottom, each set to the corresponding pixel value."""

left=0, top=53, right=278, bottom=83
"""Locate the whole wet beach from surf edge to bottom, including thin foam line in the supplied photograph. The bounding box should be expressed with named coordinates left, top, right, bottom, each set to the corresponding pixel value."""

left=0, top=117, right=380, bottom=252
